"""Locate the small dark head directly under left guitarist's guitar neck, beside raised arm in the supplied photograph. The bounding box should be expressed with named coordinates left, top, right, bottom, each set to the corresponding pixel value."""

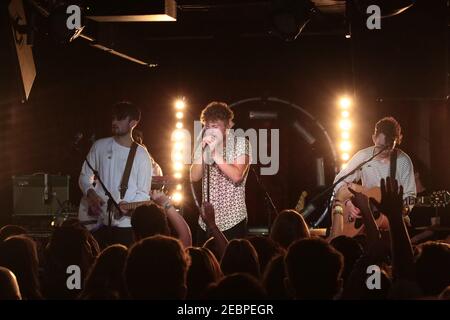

left=131, top=204, right=170, bottom=240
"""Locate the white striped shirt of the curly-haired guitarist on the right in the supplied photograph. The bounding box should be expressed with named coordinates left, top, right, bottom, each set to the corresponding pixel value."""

left=334, top=146, right=416, bottom=204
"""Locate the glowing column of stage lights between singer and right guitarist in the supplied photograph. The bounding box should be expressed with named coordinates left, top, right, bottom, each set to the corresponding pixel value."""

left=338, top=96, right=353, bottom=169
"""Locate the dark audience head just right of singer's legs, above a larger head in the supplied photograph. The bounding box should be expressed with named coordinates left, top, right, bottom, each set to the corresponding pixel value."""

left=270, top=210, right=310, bottom=249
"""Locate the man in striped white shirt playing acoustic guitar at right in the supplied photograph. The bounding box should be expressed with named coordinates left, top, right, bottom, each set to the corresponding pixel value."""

left=333, top=117, right=416, bottom=238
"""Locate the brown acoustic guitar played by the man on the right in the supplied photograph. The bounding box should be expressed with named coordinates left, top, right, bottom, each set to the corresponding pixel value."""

left=336, top=183, right=450, bottom=237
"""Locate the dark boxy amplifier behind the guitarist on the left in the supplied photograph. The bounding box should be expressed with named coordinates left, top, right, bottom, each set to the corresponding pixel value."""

left=12, top=174, right=70, bottom=216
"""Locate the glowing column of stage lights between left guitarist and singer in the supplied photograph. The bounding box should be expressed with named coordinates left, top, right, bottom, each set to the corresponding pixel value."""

left=172, top=98, right=186, bottom=203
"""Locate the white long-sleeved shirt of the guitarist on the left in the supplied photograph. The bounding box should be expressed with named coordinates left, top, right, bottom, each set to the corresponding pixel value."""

left=79, top=137, right=152, bottom=228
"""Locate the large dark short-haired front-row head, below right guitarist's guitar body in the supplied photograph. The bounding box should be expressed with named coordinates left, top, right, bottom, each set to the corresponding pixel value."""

left=285, top=238, right=344, bottom=299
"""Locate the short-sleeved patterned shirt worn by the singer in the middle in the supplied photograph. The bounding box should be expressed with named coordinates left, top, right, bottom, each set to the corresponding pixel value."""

left=198, top=133, right=251, bottom=231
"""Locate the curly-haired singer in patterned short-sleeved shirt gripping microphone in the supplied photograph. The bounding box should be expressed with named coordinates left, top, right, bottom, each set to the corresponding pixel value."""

left=190, top=102, right=251, bottom=244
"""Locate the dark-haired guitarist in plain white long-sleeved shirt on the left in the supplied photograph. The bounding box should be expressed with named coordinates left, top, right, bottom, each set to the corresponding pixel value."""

left=79, top=102, right=152, bottom=245
